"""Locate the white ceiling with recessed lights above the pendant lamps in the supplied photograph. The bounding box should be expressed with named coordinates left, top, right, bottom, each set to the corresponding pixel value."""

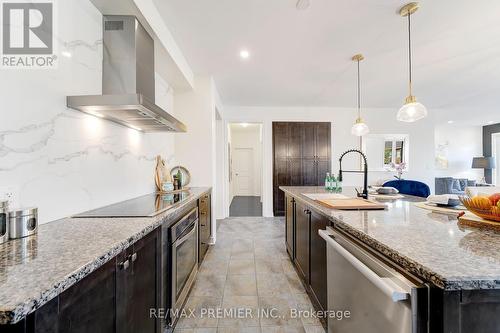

left=155, top=0, right=500, bottom=121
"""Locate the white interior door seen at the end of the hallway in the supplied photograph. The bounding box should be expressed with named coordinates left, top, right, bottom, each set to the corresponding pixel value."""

left=233, top=148, right=254, bottom=195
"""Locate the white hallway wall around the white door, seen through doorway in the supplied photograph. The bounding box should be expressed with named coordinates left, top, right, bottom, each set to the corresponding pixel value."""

left=230, top=124, right=262, bottom=198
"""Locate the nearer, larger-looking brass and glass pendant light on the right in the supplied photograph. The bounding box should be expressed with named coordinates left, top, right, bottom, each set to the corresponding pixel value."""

left=397, top=2, right=427, bottom=123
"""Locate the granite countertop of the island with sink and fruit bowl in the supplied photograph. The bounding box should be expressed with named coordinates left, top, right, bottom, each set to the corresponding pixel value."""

left=280, top=186, right=500, bottom=290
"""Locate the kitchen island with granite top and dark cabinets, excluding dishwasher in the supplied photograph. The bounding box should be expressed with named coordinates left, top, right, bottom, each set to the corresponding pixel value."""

left=281, top=187, right=500, bottom=332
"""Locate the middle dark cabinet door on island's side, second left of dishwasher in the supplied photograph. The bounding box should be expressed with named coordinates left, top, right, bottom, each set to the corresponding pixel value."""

left=294, top=202, right=311, bottom=284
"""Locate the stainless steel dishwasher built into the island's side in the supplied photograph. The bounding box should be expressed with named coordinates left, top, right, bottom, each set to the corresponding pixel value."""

left=319, top=227, right=428, bottom=333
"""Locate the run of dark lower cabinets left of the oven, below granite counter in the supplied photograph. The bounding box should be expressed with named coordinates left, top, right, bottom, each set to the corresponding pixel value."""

left=0, top=229, right=160, bottom=333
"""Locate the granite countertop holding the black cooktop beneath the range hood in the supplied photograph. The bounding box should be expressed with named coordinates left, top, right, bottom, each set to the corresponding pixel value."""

left=0, top=187, right=211, bottom=324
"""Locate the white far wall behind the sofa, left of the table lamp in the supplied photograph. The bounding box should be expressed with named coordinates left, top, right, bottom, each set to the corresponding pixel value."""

left=435, top=124, right=483, bottom=180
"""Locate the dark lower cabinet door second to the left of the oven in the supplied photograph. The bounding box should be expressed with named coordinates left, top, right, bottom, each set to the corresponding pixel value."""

left=59, top=260, right=116, bottom=333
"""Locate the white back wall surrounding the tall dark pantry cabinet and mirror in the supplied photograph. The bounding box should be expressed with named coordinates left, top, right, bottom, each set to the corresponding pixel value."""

left=225, top=106, right=434, bottom=216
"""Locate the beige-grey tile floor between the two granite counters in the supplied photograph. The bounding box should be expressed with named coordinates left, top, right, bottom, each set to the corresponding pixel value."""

left=175, top=217, right=325, bottom=333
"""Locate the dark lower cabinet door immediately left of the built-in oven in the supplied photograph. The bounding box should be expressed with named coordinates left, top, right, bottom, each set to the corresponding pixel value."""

left=116, top=231, right=160, bottom=333
